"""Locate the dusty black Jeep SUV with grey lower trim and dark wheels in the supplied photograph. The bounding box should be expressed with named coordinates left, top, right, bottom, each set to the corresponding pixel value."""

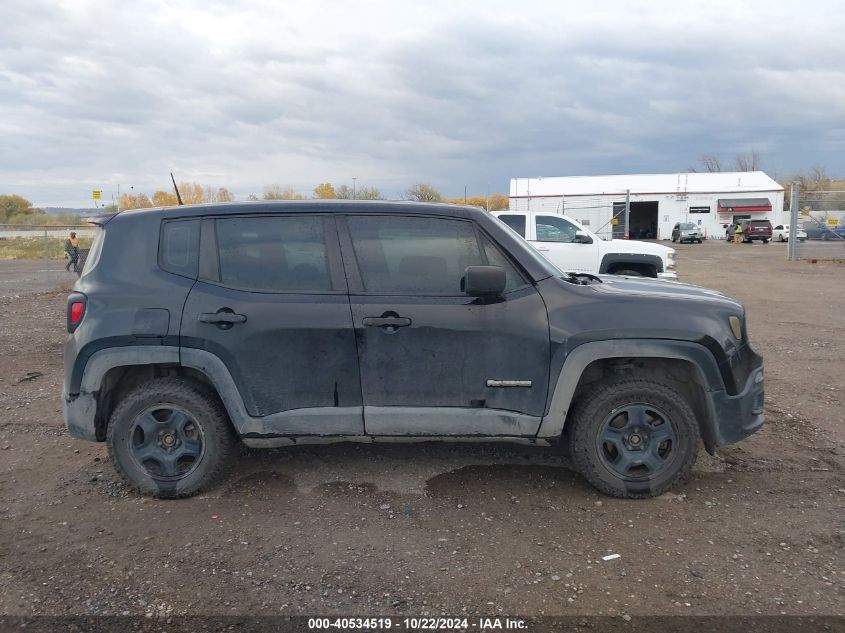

left=63, top=201, right=763, bottom=497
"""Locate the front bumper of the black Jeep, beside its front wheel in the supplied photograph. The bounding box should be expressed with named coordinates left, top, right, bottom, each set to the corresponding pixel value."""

left=708, top=366, right=765, bottom=448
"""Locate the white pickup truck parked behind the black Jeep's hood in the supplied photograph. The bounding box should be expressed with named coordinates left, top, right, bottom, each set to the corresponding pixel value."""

left=492, top=211, right=678, bottom=279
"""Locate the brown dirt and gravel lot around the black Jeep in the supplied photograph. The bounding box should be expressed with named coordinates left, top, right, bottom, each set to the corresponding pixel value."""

left=0, top=242, right=845, bottom=618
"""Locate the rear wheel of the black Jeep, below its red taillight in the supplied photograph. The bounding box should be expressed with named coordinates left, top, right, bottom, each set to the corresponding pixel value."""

left=106, top=378, right=234, bottom=498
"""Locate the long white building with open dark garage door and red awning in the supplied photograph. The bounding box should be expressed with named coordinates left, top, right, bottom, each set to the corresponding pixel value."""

left=509, top=171, right=789, bottom=240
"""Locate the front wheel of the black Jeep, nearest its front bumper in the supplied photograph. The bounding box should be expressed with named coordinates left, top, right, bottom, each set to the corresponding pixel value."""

left=567, top=378, right=699, bottom=499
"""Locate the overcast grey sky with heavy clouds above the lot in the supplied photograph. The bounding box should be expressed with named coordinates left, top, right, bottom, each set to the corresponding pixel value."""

left=0, top=0, right=845, bottom=206
